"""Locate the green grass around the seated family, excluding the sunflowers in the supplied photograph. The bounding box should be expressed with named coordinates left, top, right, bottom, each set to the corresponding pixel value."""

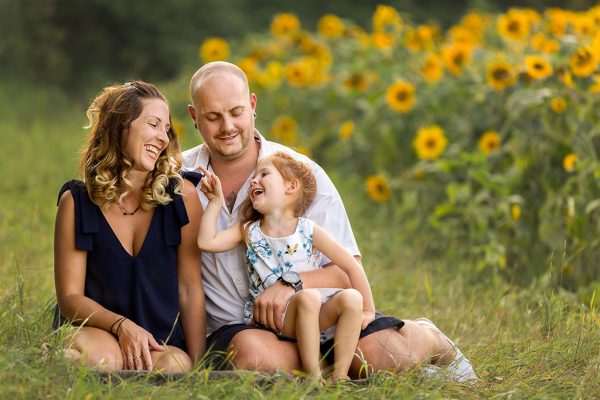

left=0, top=85, right=600, bottom=399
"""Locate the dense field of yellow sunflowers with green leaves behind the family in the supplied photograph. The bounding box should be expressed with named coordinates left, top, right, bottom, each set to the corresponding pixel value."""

left=174, top=5, right=600, bottom=288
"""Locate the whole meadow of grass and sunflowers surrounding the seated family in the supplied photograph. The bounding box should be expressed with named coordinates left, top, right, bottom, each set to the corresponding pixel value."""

left=0, top=6, right=600, bottom=400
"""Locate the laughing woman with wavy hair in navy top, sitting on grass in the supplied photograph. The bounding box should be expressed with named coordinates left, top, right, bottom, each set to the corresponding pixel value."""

left=54, top=81, right=205, bottom=372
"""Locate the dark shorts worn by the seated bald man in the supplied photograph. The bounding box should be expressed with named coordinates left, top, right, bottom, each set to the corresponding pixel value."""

left=206, top=313, right=404, bottom=369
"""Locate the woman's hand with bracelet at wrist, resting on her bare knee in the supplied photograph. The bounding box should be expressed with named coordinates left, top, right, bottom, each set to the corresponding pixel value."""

left=117, top=319, right=165, bottom=371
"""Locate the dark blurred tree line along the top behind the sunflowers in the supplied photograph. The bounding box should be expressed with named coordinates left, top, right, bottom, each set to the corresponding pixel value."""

left=0, top=0, right=595, bottom=94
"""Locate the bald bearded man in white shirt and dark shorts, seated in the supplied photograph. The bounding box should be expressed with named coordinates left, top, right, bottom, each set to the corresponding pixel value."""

left=183, top=62, right=474, bottom=380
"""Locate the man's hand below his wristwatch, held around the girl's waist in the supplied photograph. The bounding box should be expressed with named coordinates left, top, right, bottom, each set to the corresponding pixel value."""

left=253, top=282, right=295, bottom=332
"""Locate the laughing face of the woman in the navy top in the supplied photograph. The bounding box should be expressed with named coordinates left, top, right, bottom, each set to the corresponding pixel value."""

left=123, top=98, right=171, bottom=172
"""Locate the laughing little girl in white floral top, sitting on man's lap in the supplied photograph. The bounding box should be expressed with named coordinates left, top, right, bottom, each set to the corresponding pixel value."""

left=198, top=152, right=375, bottom=381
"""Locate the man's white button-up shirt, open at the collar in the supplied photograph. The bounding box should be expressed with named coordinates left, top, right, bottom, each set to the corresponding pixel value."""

left=182, top=132, right=360, bottom=334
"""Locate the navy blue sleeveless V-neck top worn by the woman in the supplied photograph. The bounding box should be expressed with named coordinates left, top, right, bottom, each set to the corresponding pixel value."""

left=53, top=180, right=200, bottom=350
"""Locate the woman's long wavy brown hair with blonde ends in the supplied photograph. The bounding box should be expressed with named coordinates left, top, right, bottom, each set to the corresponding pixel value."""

left=79, top=81, right=183, bottom=211
